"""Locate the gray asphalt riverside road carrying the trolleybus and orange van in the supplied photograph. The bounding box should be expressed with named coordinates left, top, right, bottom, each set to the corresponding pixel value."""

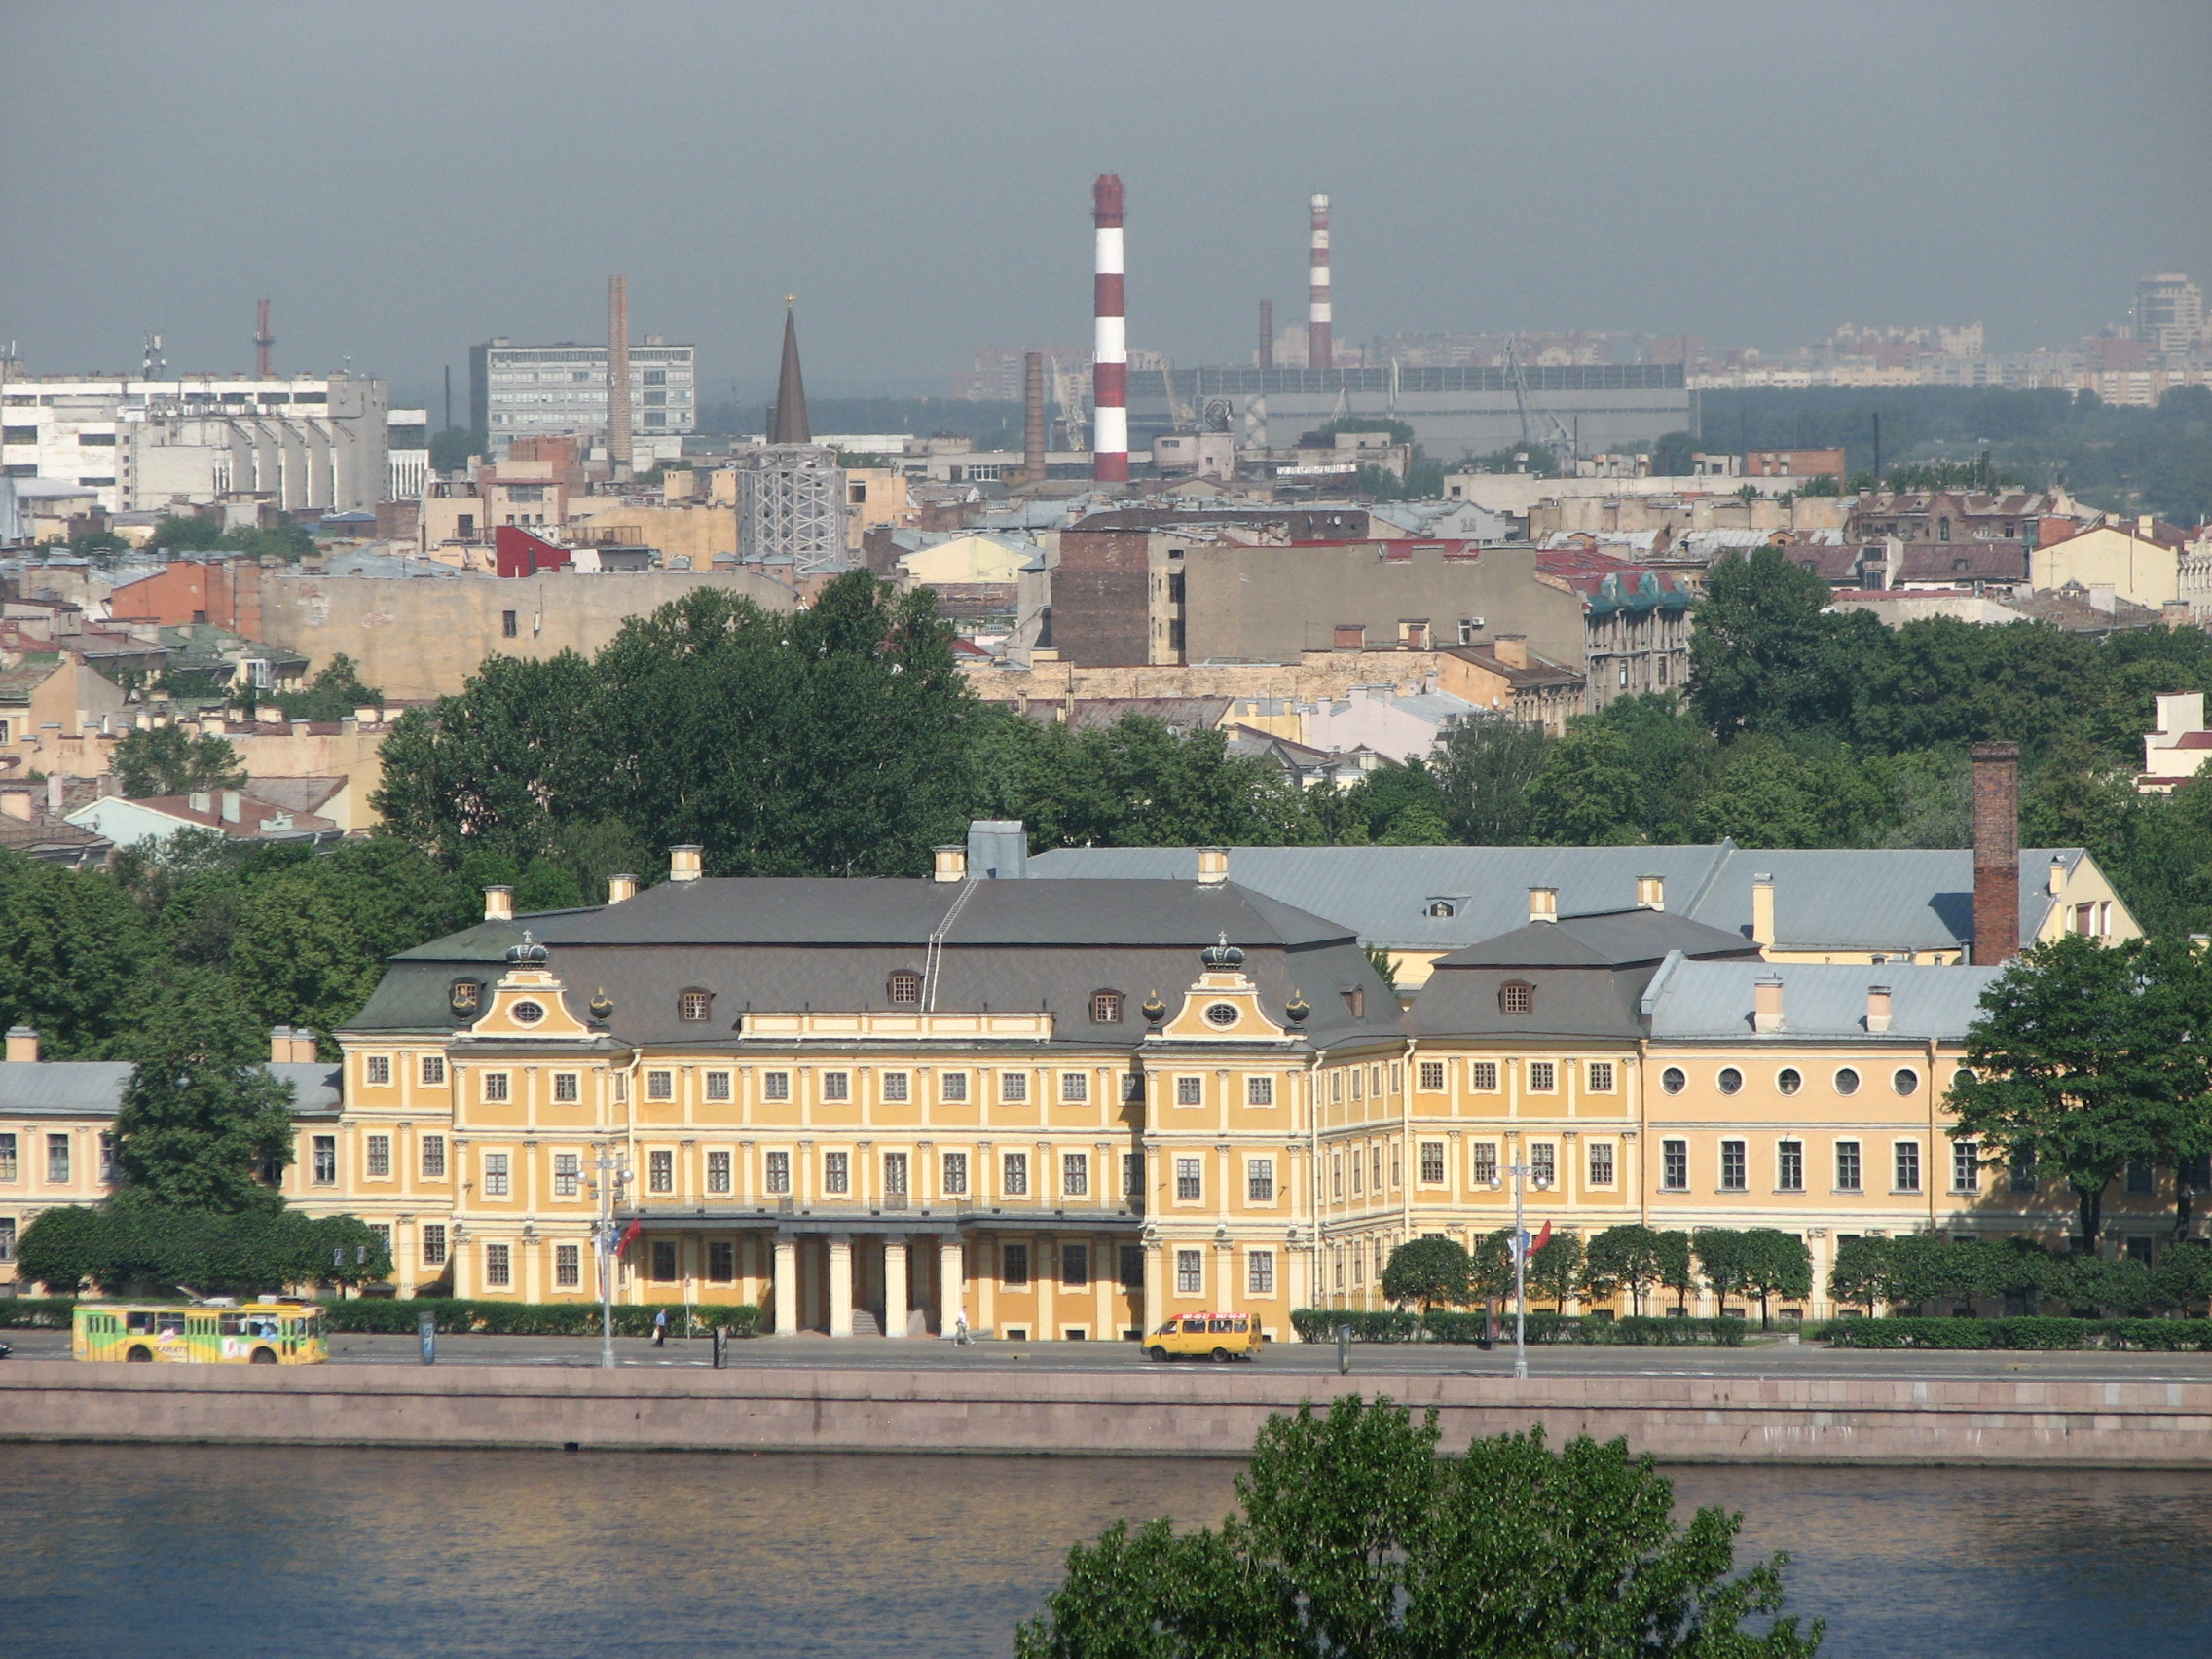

left=0, top=1332, right=2212, bottom=1382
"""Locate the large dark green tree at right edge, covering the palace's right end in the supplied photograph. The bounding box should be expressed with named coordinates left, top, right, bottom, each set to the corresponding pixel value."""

left=1951, top=936, right=2212, bottom=1252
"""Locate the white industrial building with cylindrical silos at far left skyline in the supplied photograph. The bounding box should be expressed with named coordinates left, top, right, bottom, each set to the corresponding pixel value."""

left=0, top=374, right=388, bottom=513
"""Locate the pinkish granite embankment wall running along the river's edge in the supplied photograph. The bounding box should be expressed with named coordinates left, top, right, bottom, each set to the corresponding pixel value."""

left=0, top=1360, right=2212, bottom=1469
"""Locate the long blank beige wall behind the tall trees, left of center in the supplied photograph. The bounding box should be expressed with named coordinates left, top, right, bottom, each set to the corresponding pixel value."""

left=261, top=571, right=792, bottom=699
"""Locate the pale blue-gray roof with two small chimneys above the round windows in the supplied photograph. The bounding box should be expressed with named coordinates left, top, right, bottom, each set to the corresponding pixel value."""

left=1648, top=962, right=2002, bottom=1042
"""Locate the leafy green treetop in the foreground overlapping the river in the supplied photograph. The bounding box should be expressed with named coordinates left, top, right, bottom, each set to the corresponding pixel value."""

left=1015, top=1396, right=1823, bottom=1659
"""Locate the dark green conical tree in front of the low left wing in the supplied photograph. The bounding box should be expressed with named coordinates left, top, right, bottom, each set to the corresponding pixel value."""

left=115, top=969, right=292, bottom=1214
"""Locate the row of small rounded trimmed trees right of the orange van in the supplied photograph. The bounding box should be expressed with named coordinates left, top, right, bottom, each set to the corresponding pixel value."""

left=1382, top=1223, right=1812, bottom=1325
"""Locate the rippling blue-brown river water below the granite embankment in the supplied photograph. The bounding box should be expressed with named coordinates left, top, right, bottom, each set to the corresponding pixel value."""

left=0, top=1445, right=2212, bottom=1659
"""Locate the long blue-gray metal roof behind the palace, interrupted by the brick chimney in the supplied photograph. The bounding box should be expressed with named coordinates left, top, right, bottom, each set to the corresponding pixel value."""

left=1028, top=840, right=2088, bottom=951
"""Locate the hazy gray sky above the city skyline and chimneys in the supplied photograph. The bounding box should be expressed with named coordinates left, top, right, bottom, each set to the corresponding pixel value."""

left=0, top=0, right=2212, bottom=400
